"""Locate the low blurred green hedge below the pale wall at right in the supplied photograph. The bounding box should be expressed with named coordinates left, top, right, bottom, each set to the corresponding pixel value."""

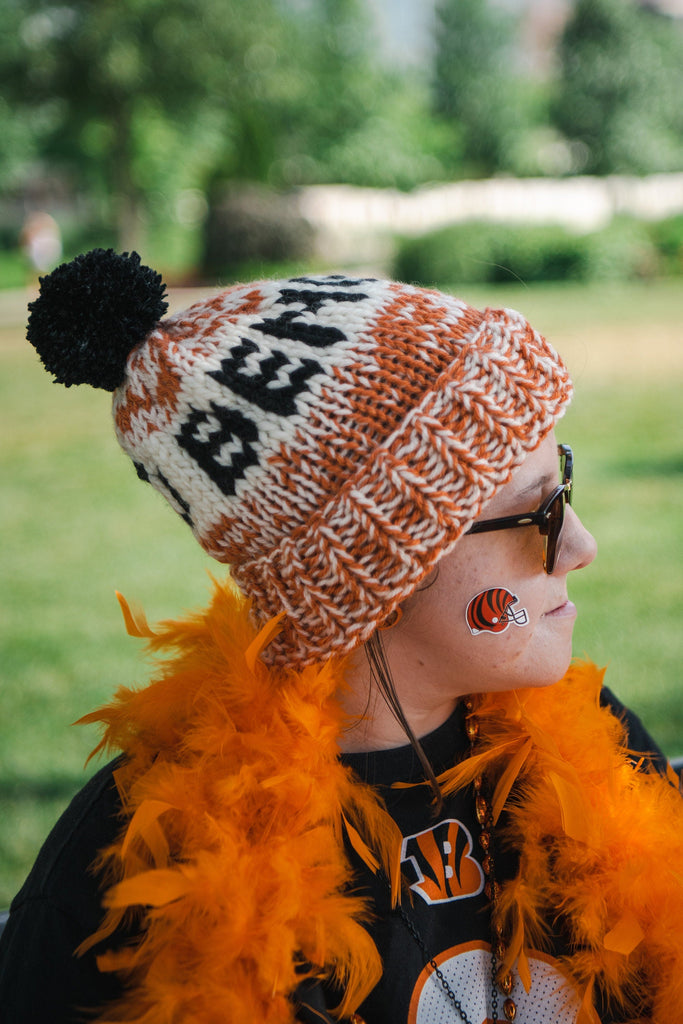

left=393, top=216, right=683, bottom=287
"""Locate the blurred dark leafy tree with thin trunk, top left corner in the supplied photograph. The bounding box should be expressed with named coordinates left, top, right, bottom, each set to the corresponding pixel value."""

left=0, top=0, right=286, bottom=246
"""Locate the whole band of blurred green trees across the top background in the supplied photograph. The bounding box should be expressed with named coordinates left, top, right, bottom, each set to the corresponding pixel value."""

left=0, top=0, right=683, bottom=263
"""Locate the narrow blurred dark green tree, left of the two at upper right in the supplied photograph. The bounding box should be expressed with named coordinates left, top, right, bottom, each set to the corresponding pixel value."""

left=433, top=0, right=527, bottom=175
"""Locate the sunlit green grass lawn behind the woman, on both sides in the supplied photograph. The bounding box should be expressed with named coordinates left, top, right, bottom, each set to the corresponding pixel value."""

left=0, top=283, right=683, bottom=906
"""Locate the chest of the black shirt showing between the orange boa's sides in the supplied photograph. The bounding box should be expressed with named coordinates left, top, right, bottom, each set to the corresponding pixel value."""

left=344, top=708, right=578, bottom=1024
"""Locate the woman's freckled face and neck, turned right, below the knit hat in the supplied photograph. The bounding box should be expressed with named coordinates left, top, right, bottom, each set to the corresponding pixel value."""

left=366, top=433, right=597, bottom=734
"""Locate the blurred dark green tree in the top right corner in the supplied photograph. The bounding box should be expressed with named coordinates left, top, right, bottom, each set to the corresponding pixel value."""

left=552, top=0, right=683, bottom=174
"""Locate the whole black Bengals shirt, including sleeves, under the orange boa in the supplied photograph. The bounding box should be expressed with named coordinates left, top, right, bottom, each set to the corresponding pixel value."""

left=0, top=691, right=664, bottom=1024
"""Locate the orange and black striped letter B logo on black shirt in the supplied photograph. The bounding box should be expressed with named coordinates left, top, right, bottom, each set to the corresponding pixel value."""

left=400, top=818, right=484, bottom=904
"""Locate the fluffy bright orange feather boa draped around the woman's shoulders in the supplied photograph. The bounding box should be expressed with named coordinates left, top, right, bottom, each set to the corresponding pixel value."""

left=77, top=584, right=683, bottom=1024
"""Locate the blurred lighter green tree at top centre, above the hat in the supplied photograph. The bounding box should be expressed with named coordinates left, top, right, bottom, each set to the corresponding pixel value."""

left=210, top=0, right=450, bottom=187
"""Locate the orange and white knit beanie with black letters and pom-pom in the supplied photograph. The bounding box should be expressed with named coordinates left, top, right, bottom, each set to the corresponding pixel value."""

left=28, top=250, right=571, bottom=666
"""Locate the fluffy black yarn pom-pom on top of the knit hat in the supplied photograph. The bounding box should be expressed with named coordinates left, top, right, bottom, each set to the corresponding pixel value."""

left=27, top=249, right=168, bottom=391
